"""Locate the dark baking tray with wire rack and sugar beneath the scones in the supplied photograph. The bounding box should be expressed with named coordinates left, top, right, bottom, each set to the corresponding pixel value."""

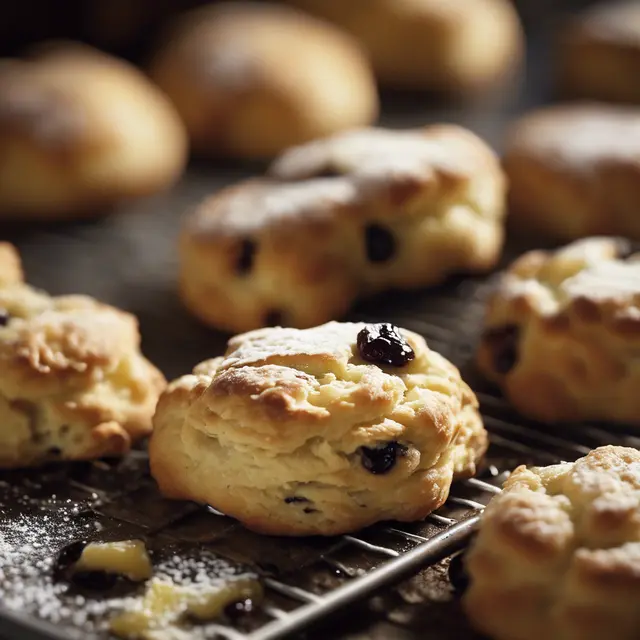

left=0, top=3, right=640, bottom=640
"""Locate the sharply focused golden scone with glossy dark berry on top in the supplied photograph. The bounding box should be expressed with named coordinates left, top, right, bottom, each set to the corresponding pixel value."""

left=149, top=322, right=487, bottom=536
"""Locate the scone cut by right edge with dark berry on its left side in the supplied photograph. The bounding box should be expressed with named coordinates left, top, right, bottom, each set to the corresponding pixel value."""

left=478, top=238, right=640, bottom=425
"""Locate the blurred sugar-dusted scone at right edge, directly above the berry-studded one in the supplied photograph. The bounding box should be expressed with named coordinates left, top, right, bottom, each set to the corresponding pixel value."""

left=504, top=104, right=640, bottom=240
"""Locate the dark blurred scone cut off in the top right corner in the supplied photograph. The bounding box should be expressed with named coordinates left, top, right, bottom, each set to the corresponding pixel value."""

left=559, top=0, right=640, bottom=104
